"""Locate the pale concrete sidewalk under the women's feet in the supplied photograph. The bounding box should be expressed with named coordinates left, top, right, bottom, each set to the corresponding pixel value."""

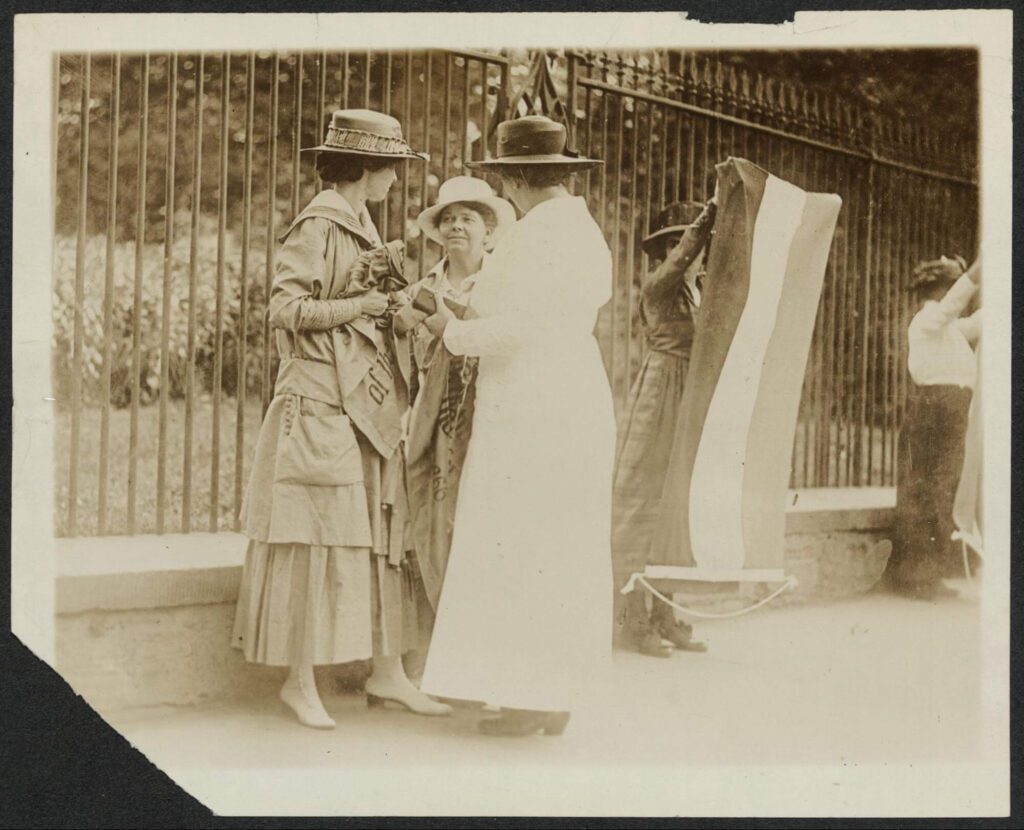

left=103, top=585, right=982, bottom=815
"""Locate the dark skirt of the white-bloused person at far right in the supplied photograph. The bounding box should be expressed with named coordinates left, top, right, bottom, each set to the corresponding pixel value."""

left=888, top=384, right=971, bottom=584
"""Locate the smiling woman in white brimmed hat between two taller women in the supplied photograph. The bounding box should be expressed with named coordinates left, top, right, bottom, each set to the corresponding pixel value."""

left=399, top=176, right=515, bottom=630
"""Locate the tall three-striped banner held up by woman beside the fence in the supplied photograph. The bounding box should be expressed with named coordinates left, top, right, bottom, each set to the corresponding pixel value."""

left=645, top=159, right=842, bottom=581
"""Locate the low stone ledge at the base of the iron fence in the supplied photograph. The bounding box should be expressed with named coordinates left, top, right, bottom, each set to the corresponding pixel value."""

left=55, top=489, right=894, bottom=711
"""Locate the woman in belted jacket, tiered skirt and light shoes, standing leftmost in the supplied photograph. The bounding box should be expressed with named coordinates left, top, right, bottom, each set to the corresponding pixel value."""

left=233, top=110, right=450, bottom=728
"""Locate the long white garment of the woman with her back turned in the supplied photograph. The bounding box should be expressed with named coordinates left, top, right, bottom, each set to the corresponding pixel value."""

left=422, top=196, right=615, bottom=710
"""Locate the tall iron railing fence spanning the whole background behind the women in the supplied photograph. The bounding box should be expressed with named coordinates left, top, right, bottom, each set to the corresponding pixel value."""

left=53, top=50, right=977, bottom=535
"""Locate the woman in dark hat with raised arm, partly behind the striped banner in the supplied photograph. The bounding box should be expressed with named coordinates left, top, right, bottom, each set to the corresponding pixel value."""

left=611, top=202, right=715, bottom=657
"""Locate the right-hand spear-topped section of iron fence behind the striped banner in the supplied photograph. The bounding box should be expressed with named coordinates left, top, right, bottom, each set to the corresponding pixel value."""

left=566, top=51, right=977, bottom=499
